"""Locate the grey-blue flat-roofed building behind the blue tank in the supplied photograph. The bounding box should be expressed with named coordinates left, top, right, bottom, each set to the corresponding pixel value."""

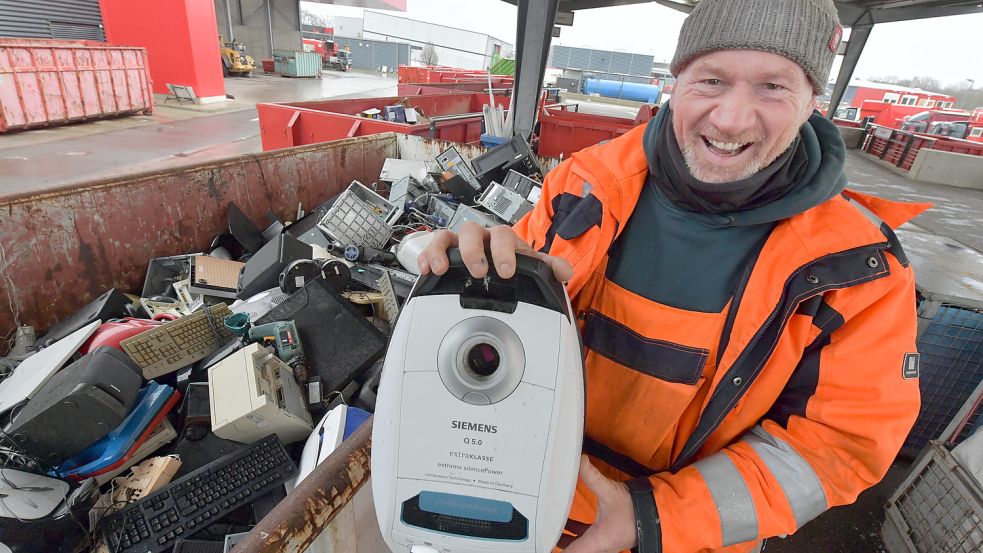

left=547, top=44, right=654, bottom=84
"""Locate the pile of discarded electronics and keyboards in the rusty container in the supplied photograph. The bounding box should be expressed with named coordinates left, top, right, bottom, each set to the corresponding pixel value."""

left=0, top=138, right=544, bottom=553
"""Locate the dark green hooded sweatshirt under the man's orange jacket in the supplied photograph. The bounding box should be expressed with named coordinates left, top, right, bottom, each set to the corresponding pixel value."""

left=607, top=106, right=846, bottom=313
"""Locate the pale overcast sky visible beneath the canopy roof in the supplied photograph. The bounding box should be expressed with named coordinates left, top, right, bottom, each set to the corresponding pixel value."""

left=304, top=0, right=983, bottom=87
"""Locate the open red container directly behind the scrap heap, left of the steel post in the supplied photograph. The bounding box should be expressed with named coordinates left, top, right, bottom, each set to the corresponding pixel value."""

left=256, top=92, right=509, bottom=151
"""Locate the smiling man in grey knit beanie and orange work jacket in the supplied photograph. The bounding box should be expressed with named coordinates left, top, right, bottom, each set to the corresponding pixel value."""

left=419, top=0, right=924, bottom=553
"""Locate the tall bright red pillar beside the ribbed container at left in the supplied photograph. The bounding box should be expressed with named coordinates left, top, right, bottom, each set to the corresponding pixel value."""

left=99, top=0, right=225, bottom=101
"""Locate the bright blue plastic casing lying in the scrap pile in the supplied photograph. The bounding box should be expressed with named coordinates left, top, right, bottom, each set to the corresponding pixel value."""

left=54, top=381, right=174, bottom=478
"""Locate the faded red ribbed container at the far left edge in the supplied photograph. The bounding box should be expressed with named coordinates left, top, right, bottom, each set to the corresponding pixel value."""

left=0, top=38, right=154, bottom=132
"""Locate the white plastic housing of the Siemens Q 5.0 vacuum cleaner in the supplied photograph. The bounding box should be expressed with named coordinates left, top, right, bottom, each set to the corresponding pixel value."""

left=372, top=295, right=584, bottom=553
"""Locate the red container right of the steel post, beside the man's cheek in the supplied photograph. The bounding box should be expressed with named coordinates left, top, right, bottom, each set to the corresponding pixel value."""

left=538, top=105, right=659, bottom=157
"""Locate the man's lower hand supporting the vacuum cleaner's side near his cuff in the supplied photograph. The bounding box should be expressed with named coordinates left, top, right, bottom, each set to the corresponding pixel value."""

left=564, top=455, right=637, bottom=553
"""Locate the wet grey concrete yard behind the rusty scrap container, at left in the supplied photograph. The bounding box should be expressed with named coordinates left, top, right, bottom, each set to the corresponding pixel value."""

left=0, top=71, right=396, bottom=196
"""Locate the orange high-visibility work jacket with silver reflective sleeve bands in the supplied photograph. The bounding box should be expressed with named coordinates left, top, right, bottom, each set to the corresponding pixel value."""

left=514, top=126, right=927, bottom=553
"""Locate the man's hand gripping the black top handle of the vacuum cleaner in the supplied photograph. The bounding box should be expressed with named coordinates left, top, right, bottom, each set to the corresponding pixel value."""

left=417, top=222, right=573, bottom=282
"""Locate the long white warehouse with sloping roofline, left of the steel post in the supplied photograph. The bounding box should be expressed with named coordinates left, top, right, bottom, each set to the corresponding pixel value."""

left=362, top=11, right=513, bottom=69
